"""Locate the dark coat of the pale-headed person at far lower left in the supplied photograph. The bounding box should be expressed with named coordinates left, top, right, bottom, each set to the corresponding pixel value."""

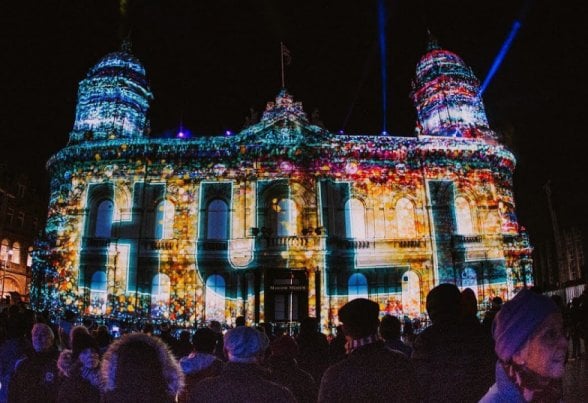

left=8, top=352, right=60, bottom=403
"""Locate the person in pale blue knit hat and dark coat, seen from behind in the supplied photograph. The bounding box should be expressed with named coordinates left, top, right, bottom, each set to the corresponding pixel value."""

left=188, top=326, right=296, bottom=403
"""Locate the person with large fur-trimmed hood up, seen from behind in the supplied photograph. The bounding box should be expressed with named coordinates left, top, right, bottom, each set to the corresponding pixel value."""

left=102, top=333, right=184, bottom=403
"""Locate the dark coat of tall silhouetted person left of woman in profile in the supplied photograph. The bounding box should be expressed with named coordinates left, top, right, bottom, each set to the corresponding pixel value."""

left=411, top=317, right=496, bottom=402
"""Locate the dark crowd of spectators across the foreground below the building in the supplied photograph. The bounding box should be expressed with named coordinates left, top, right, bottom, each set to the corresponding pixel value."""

left=0, top=284, right=588, bottom=403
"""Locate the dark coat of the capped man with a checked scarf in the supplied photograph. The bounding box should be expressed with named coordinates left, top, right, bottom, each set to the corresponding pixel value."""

left=318, top=342, right=419, bottom=402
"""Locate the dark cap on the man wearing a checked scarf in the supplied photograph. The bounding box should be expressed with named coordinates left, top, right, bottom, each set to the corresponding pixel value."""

left=339, top=298, right=380, bottom=338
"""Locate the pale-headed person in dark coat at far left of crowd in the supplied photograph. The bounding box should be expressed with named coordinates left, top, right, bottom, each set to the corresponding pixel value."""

left=7, top=323, right=60, bottom=403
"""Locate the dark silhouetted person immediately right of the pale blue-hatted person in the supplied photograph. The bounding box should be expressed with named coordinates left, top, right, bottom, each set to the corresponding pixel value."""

left=267, top=335, right=318, bottom=402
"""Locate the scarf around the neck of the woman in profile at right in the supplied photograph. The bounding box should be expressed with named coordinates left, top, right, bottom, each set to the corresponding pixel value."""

left=501, top=362, right=563, bottom=403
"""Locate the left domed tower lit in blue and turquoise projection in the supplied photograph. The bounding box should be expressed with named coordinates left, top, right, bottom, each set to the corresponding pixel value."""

left=70, top=42, right=153, bottom=143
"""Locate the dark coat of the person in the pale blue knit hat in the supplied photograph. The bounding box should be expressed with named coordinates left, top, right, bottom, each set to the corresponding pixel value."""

left=188, top=362, right=296, bottom=403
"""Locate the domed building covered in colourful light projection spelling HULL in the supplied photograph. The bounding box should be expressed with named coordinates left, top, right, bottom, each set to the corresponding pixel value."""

left=31, top=38, right=532, bottom=328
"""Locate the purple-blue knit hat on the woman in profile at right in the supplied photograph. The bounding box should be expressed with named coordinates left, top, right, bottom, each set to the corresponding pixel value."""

left=492, top=289, right=559, bottom=362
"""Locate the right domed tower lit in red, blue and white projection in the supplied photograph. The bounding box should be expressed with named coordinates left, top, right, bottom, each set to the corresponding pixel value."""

left=411, top=37, right=495, bottom=139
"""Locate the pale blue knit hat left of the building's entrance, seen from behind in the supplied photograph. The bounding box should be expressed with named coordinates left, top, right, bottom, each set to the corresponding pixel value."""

left=224, top=326, right=269, bottom=362
